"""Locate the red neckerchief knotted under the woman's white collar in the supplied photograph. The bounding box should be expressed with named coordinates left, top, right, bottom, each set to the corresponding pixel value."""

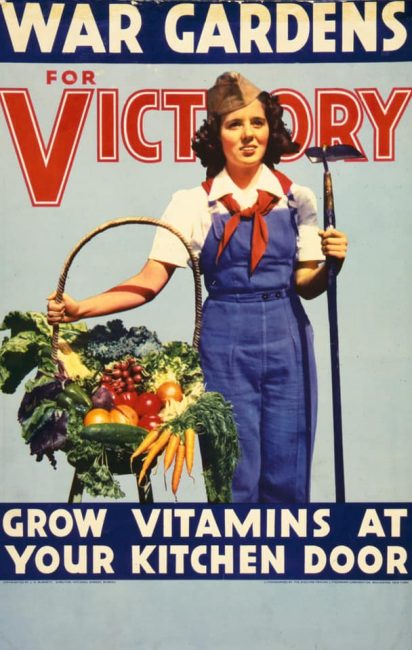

left=202, top=170, right=292, bottom=273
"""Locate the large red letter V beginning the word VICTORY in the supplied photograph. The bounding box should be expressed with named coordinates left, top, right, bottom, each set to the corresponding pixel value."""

left=0, top=88, right=93, bottom=206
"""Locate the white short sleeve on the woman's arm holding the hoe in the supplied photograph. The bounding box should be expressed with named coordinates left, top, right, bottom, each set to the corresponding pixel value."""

left=291, top=184, right=325, bottom=262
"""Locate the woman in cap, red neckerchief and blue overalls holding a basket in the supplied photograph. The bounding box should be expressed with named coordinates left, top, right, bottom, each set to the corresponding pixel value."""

left=48, top=73, right=347, bottom=503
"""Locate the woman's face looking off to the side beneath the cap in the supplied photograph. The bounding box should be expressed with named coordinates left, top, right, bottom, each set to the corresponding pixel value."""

left=220, top=99, right=269, bottom=169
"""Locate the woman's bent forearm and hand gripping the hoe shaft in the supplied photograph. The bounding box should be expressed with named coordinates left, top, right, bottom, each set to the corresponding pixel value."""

left=295, top=229, right=348, bottom=300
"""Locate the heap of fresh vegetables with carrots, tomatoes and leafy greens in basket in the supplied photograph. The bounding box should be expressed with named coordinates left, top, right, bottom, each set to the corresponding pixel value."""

left=0, top=312, right=239, bottom=502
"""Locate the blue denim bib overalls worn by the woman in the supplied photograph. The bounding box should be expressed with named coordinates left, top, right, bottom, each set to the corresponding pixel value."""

left=200, top=182, right=317, bottom=503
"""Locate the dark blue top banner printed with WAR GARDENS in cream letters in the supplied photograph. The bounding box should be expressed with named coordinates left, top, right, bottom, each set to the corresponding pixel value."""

left=0, top=0, right=412, bottom=65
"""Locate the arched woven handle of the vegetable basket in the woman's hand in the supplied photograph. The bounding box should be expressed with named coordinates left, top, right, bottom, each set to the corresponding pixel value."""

left=52, top=217, right=202, bottom=364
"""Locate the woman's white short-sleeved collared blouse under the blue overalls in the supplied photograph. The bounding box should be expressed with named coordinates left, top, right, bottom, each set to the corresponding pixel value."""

left=149, top=165, right=325, bottom=267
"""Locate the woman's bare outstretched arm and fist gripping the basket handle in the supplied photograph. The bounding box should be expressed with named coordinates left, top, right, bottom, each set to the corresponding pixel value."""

left=47, top=260, right=176, bottom=325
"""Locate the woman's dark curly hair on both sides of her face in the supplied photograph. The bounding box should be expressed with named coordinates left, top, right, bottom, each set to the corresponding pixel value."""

left=192, top=92, right=300, bottom=178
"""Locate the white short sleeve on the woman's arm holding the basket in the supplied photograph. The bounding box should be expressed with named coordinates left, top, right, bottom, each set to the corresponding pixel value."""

left=149, top=190, right=200, bottom=267
